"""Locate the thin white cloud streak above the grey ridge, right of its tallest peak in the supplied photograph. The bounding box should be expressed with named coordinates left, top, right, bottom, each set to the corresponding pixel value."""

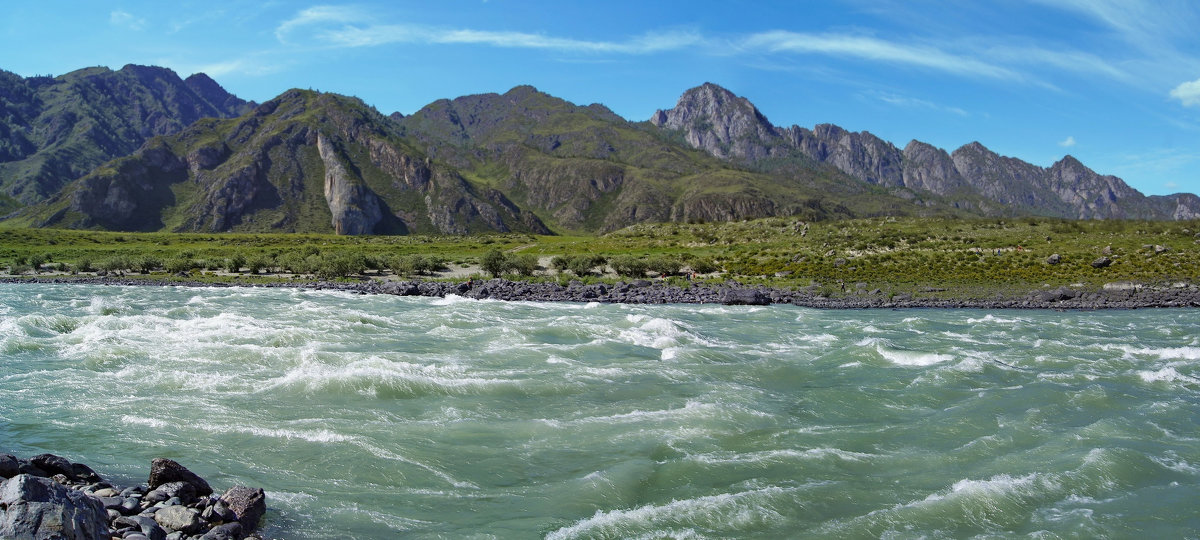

left=740, top=30, right=1024, bottom=80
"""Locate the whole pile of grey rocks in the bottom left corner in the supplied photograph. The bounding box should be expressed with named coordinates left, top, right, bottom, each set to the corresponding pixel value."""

left=0, top=454, right=266, bottom=540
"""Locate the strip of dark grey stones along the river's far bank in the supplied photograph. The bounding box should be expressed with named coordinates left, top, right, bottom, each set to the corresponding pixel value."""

left=0, top=276, right=1200, bottom=310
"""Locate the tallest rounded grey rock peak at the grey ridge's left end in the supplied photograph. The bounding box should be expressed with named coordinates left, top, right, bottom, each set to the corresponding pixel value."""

left=650, top=83, right=780, bottom=160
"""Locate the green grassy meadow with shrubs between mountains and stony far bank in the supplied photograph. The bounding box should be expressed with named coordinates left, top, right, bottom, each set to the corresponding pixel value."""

left=0, top=218, right=1200, bottom=296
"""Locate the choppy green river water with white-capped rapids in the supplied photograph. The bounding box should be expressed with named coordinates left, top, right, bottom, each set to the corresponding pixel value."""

left=0, top=284, right=1200, bottom=539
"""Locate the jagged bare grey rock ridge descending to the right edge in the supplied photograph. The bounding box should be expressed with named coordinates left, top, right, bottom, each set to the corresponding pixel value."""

left=650, top=83, right=1200, bottom=220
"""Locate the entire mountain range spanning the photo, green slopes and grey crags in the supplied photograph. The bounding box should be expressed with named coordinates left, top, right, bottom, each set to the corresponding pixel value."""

left=0, top=66, right=1200, bottom=234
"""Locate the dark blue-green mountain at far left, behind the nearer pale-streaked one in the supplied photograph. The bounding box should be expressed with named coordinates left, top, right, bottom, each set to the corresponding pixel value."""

left=0, top=65, right=252, bottom=204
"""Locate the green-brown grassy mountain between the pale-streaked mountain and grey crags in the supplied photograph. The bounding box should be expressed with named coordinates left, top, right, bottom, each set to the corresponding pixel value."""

left=398, top=86, right=950, bottom=233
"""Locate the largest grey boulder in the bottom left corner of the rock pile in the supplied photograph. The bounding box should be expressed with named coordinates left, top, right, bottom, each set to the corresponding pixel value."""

left=0, top=474, right=108, bottom=540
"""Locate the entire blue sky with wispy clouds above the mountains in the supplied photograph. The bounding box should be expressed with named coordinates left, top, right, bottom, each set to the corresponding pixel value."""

left=0, top=0, right=1200, bottom=194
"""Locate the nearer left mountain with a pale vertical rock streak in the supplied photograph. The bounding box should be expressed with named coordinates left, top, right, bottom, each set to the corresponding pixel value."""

left=14, top=90, right=548, bottom=234
